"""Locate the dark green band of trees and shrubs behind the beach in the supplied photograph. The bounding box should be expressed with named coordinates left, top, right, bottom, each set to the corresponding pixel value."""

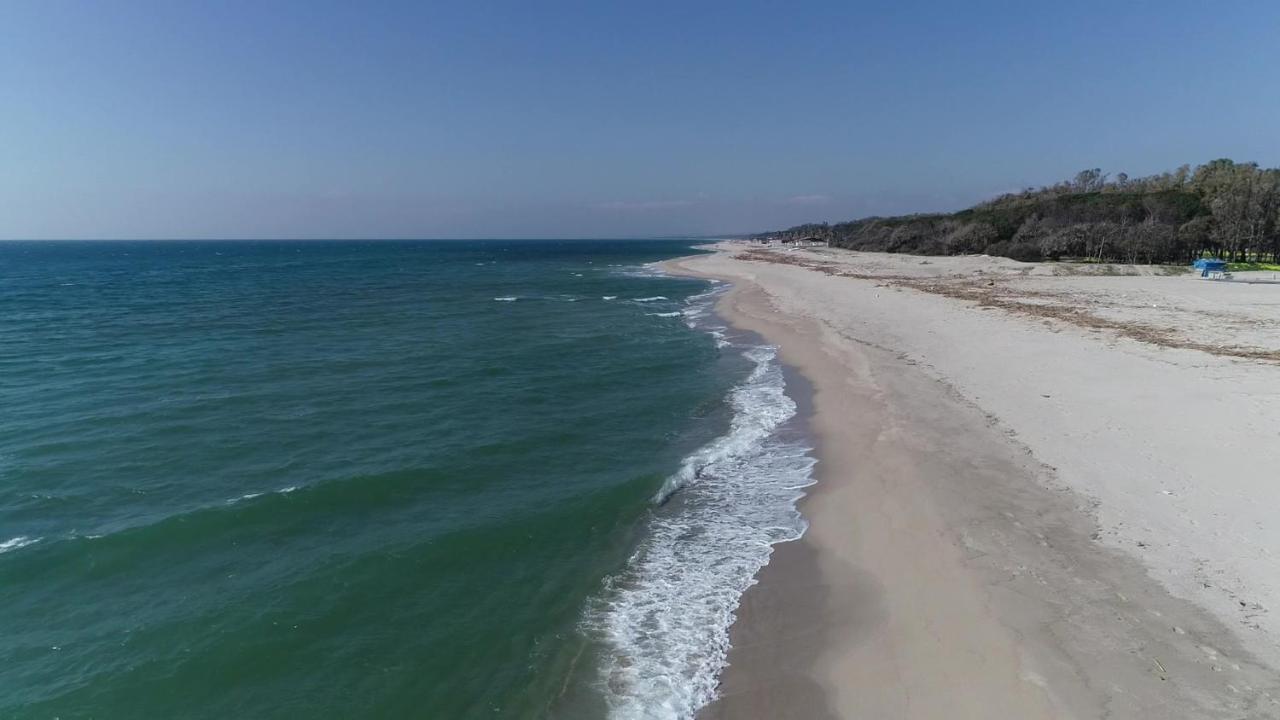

left=756, top=159, right=1280, bottom=264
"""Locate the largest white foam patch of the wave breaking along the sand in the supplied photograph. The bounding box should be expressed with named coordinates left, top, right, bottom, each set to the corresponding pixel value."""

left=585, top=330, right=814, bottom=720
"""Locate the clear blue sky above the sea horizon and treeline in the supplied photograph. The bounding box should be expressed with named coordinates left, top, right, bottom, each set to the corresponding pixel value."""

left=0, top=0, right=1280, bottom=238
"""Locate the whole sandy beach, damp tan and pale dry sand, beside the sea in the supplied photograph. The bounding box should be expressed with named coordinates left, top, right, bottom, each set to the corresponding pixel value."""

left=668, top=243, right=1280, bottom=719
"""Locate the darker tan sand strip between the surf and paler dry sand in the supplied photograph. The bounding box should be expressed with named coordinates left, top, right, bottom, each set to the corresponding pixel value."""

left=664, top=244, right=1280, bottom=719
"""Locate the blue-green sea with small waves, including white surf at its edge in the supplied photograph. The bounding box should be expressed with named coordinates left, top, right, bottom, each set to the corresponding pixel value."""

left=0, top=240, right=814, bottom=720
